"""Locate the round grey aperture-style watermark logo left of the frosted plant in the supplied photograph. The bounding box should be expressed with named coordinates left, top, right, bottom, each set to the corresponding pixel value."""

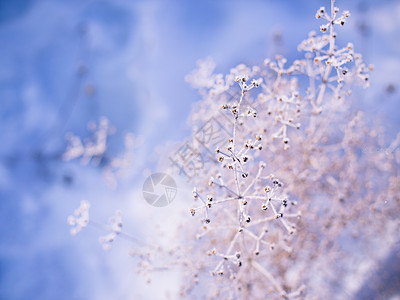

left=142, top=173, right=177, bottom=207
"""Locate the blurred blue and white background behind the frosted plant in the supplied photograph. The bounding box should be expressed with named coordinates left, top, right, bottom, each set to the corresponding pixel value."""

left=0, top=0, right=400, bottom=299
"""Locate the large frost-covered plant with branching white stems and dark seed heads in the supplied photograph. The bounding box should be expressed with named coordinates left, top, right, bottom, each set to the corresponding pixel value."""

left=67, top=0, right=400, bottom=299
